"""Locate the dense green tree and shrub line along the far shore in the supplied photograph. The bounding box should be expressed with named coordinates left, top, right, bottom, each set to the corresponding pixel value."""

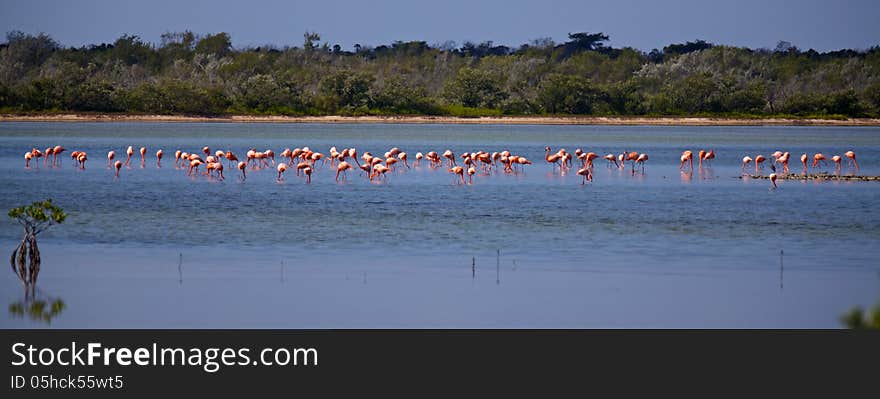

left=0, top=31, right=880, bottom=117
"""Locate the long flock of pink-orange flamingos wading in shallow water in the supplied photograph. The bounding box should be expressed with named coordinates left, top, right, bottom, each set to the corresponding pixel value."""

left=18, top=146, right=859, bottom=189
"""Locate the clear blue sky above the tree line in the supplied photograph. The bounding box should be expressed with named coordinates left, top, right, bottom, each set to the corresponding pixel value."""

left=0, top=0, right=880, bottom=51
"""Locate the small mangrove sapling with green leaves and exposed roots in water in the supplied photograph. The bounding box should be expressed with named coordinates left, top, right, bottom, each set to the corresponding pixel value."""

left=9, top=199, right=67, bottom=299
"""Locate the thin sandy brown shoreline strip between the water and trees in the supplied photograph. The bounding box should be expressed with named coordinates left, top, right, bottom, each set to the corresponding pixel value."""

left=0, top=114, right=880, bottom=126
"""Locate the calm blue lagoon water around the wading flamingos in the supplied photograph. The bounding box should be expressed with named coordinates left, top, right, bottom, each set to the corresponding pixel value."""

left=0, top=123, right=880, bottom=328
